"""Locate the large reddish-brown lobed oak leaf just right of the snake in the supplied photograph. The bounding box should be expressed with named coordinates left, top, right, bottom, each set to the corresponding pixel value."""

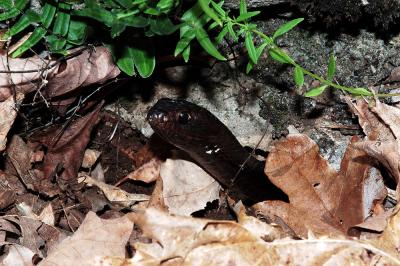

left=254, top=134, right=369, bottom=237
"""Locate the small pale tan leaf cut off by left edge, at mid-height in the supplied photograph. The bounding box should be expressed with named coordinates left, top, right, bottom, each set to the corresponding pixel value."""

left=0, top=93, right=24, bottom=151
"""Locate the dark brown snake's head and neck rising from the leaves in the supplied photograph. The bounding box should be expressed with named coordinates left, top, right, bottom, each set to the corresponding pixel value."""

left=147, top=98, right=287, bottom=202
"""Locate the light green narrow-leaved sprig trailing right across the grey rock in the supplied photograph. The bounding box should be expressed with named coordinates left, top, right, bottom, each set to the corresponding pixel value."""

left=189, top=0, right=380, bottom=97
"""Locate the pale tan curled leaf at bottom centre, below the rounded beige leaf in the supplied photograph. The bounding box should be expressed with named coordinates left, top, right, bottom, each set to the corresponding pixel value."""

left=131, top=208, right=262, bottom=259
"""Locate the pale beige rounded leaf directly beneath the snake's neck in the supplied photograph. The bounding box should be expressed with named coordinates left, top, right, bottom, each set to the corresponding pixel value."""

left=160, top=159, right=220, bottom=215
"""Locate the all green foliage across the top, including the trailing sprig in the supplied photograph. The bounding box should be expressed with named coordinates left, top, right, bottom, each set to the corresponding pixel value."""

left=0, top=0, right=396, bottom=97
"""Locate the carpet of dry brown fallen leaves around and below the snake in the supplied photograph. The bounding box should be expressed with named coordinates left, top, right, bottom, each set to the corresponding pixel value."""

left=0, top=48, right=400, bottom=265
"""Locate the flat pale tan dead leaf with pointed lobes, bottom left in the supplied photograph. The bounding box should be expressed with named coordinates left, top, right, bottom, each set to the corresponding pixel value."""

left=39, top=212, right=133, bottom=266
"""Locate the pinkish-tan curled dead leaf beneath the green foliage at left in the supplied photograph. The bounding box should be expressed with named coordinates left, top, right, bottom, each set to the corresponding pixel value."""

left=0, top=47, right=120, bottom=101
